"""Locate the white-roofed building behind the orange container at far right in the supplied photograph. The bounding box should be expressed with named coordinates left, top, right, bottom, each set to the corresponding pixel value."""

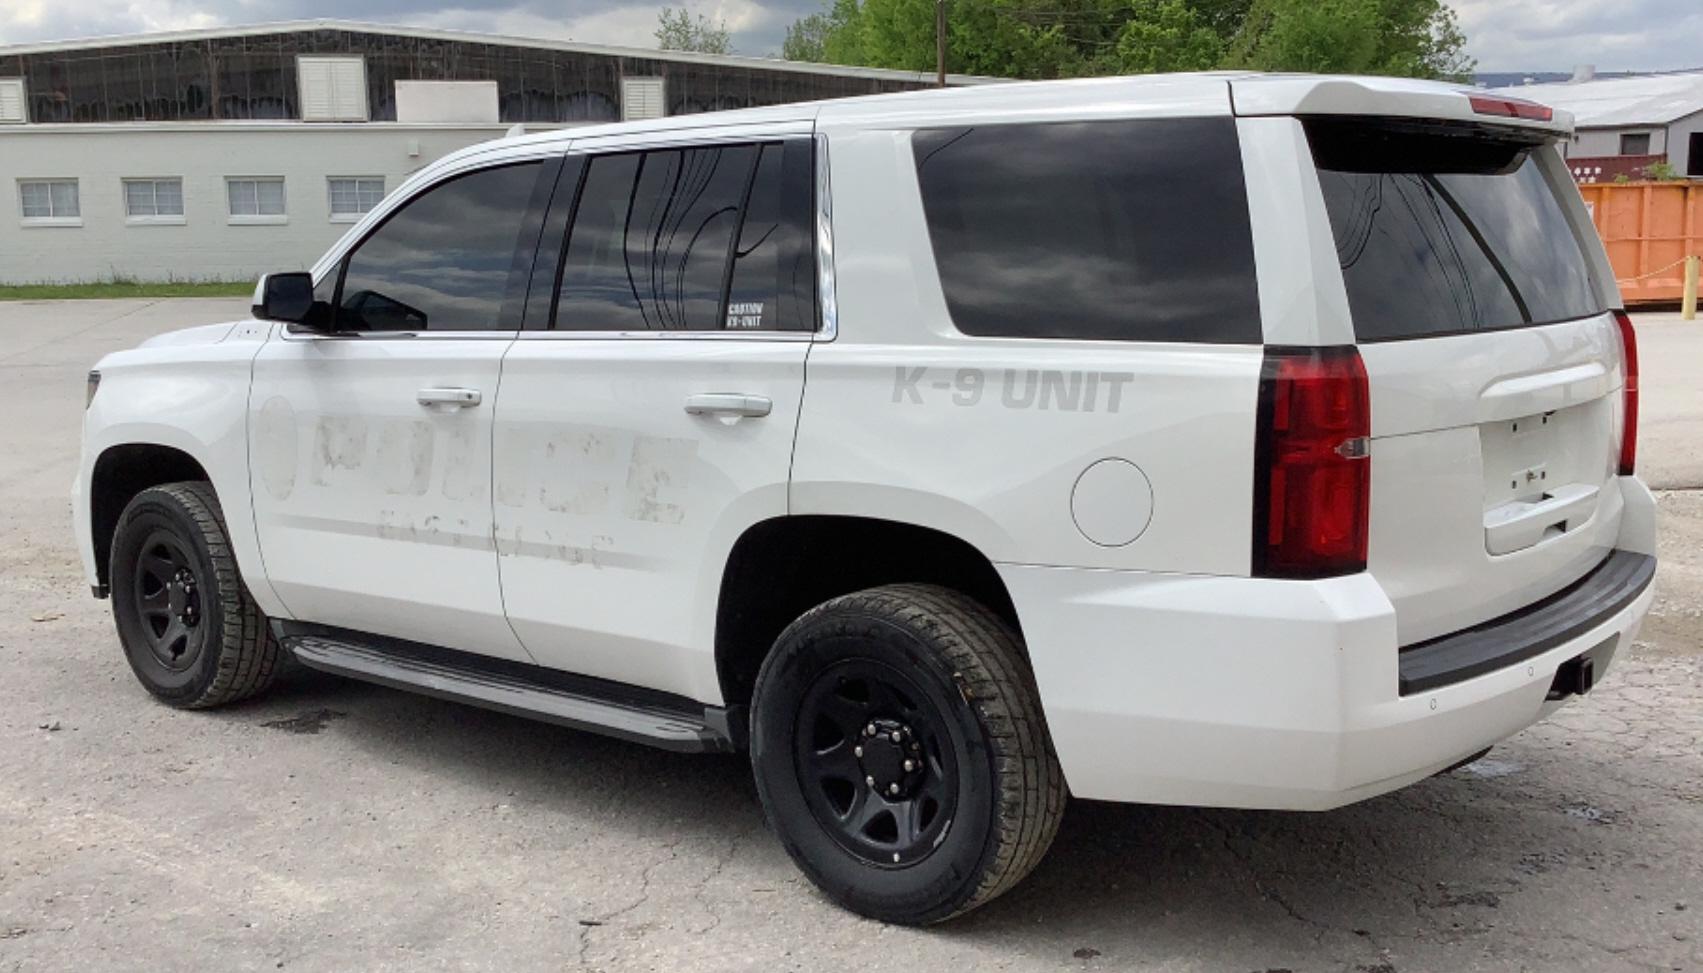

left=1502, top=68, right=1703, bottom=182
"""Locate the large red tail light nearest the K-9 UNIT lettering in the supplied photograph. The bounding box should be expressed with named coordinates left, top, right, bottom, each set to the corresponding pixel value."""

left=1253, top=346, right=1373, bottom=578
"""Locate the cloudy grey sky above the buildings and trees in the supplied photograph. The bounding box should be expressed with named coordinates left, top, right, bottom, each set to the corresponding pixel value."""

left=0, top=0, right=1703, bottom=72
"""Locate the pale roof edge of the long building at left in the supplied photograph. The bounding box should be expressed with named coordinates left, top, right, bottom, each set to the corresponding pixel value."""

left=0, top=19, right=1003, bottom=85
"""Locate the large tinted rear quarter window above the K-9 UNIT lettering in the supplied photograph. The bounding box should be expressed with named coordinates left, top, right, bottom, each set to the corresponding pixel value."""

left=913, top=118, right=1260, bottom=343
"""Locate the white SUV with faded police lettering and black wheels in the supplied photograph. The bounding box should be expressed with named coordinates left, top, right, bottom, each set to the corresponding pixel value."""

left=77, top=75, right=1655, bottom=922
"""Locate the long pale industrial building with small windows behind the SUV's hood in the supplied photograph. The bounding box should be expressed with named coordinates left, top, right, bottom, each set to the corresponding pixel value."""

left=0, top=20, right=979, bottom=283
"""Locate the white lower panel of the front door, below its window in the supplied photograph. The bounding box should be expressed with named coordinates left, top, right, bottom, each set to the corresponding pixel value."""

left=249, top=336, right=528, bottom=659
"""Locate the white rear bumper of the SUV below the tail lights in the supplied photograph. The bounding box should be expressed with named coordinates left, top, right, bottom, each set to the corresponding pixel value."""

left=1000, top=477, right=1654, bottom=809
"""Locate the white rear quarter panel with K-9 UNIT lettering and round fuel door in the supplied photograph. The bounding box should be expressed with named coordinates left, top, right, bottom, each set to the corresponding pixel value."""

left=792, top=83, right=1260, bottom=574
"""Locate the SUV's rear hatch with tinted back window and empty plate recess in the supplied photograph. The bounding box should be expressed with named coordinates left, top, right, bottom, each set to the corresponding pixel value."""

left=1303, top=114, right=1623, bottom=644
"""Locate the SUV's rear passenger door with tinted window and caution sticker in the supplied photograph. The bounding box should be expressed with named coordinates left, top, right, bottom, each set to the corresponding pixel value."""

left=496, top=140, right=816, bottom=702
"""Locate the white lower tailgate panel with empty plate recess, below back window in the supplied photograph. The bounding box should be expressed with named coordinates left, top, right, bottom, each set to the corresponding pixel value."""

left=1361, top=315, right=1625, bottom=644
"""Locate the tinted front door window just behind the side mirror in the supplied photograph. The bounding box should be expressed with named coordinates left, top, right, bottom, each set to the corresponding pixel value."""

left=337, top=162, right=542, bottom=331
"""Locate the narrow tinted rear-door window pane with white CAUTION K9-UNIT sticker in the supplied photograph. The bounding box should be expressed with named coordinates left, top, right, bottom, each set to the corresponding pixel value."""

left=727, top=140, right=816, bottom=331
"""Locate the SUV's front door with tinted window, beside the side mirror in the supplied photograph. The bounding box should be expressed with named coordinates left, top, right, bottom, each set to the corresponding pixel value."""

left=249, top=162, right=548, bottom=659
